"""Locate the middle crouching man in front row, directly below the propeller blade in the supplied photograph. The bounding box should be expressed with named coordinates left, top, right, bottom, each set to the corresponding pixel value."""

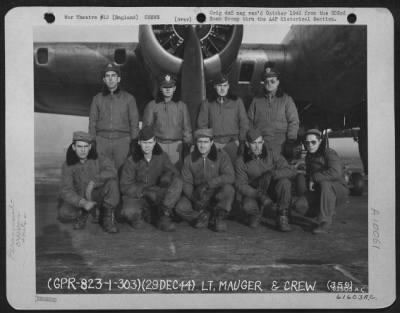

left=175, top=128, right=235, bottom=232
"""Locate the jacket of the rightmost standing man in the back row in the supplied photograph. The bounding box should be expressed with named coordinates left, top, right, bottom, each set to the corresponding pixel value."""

left=248, top=93, right=299, bottom=139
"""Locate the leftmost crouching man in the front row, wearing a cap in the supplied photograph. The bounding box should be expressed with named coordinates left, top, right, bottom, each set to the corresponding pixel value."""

left=58, top=131, right=120, bottom=233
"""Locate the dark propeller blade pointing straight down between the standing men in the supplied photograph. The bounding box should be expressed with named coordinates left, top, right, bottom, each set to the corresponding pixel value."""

left=181, top=25, right=206, bottom=130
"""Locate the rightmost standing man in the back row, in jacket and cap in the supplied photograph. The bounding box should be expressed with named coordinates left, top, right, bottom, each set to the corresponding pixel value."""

left=248, top=67, right=299, bottom=153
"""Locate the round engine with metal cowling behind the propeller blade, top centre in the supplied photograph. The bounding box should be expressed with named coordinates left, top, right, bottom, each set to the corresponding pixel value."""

left=139, top=25, right=243, bottom=80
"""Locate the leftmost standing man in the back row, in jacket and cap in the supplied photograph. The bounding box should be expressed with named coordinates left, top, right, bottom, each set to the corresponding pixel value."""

left=89, top=64, right=139, bottom=169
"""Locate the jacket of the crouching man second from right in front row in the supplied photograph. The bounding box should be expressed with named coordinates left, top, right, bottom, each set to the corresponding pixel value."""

left=235, top=146, right=294, bottom=197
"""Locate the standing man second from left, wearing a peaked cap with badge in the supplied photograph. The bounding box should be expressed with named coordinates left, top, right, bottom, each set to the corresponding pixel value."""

left=143, top=75, right=192, bottom=167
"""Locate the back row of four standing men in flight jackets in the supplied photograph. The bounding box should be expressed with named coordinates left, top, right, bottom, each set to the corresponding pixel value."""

left=89, top=64, right=299, bottom=169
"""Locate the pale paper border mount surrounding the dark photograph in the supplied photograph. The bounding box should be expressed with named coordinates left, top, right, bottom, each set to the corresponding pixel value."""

left=5, top=7, right=396, bottom=309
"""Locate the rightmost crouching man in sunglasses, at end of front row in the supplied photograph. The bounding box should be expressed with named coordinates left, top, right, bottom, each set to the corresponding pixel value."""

left=294, top=129, right=349, bottom=234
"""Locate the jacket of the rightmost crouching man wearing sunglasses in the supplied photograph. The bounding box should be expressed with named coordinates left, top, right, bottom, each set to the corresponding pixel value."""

left=306, top=144, right=347, bottom=186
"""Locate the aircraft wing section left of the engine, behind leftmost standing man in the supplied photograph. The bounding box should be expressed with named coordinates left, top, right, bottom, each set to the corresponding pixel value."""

left=34, top=42, right=152, bottom=116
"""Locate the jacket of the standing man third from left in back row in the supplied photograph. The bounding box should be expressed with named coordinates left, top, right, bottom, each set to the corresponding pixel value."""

left=197, top=98, right=249, bottom=143
